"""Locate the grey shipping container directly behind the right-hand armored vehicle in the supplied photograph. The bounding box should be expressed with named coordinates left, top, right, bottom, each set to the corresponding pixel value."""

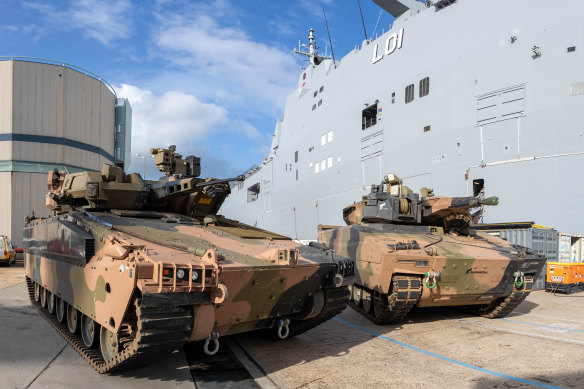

left=472, top=222, right=559, bottom=290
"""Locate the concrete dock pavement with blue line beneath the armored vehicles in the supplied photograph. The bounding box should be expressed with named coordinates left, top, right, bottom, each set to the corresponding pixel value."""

left=0, top=263, right=584, bottom=389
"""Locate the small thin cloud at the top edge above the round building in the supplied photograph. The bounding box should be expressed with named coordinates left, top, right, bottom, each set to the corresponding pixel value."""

left=23, top=0, right=132, bottom=45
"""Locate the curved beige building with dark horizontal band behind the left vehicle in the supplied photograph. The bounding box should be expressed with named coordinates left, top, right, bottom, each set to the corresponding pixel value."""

left=0, top=59, right=131, bottom=245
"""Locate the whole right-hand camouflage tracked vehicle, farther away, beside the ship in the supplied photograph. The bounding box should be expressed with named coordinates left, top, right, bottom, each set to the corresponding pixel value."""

left=319, top=174, right=545, bottom=324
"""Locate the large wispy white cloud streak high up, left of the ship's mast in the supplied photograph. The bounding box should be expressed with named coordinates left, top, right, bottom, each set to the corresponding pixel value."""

left=154, top=12, right=297, bottom=113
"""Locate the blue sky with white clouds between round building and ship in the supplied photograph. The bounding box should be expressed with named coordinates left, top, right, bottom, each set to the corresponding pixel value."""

left=0, top=0, right=393, bottom=178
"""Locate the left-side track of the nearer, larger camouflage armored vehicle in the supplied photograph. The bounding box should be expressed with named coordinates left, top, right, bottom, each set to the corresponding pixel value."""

left=26, top=277, right=193, bottom=374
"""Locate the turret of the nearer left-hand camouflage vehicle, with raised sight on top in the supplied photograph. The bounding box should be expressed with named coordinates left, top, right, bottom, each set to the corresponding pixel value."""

left=47, top=145, right=242, bottom=220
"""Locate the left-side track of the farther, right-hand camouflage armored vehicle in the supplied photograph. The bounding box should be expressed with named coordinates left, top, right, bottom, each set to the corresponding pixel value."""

left=350, top=275, right=422, bottom=324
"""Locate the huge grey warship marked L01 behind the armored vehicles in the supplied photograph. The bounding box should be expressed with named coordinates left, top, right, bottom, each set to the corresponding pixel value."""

left=221, top=0, right=584, bottom=240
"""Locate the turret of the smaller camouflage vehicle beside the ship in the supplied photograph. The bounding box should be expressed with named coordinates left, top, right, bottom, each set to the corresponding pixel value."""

left=343, top=174, right=499, bottom=234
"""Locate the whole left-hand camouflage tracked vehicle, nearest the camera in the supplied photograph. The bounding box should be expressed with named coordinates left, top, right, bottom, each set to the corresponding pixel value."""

left=24, top=146, right=354, bottom=373
